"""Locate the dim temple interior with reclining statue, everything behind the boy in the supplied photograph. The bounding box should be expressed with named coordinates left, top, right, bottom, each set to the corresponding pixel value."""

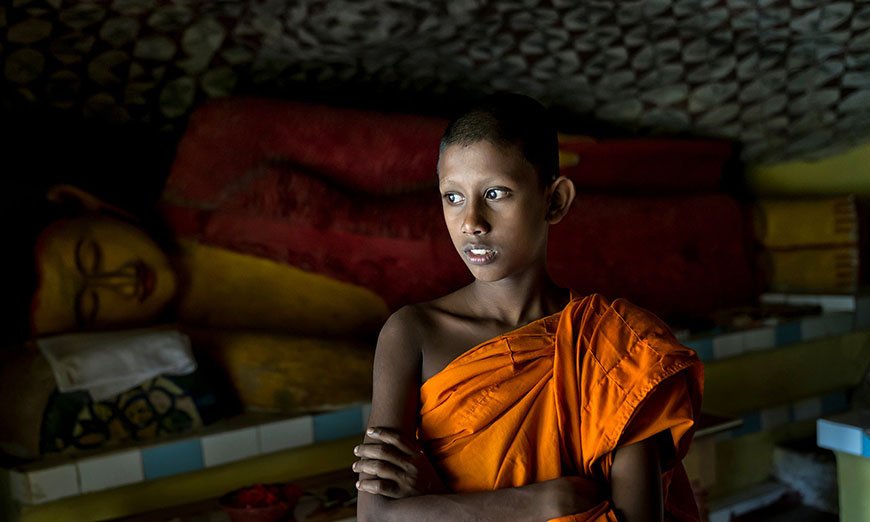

left=0, top=0, right=870, bottom=522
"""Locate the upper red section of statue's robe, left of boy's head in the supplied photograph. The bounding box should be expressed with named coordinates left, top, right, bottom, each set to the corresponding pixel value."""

left=166, top=98, right=447, bottom=197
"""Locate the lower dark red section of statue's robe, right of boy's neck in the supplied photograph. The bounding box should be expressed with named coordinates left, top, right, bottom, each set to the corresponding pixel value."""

left=548, top=193, right=753, bottom=317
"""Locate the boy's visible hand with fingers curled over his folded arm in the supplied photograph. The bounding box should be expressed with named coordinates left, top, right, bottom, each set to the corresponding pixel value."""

left=353, top=428, right=448, bottom=498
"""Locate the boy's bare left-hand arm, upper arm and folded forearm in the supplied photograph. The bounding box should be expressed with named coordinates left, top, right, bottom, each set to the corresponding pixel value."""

left=357, top=308, right=598, bottom=522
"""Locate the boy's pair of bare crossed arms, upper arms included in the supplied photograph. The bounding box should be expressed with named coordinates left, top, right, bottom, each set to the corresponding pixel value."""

left=354, top=308, right=667, bottom=522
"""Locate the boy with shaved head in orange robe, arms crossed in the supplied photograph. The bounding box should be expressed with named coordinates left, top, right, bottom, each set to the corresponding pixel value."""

left=353, top=95, right=703, bottom=522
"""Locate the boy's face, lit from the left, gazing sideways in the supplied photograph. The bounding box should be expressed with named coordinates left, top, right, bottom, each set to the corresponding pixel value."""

left=438, top=141, right=548, bottom=281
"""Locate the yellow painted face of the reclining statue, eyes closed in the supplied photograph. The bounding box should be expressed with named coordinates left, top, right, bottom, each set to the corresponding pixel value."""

left=31, top=213, right=176, bottom=335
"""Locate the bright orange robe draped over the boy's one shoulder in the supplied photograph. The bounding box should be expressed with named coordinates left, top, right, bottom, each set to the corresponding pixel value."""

left=418, top=295, right=703, bottom=522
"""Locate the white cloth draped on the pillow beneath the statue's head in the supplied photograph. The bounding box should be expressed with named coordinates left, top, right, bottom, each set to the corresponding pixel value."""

left=36, top=328, right=196, bottom=401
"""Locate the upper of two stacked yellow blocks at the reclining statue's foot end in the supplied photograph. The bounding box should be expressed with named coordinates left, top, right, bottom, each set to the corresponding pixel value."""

left=755, top=196, right=858, bottom=248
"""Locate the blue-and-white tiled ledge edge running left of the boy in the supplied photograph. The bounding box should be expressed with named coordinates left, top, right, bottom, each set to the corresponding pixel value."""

left=8, top=398, right=371, bottom=505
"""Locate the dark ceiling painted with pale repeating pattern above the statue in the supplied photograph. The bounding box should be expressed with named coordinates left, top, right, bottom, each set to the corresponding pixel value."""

left=0, top=0, right=870, bottom=163
